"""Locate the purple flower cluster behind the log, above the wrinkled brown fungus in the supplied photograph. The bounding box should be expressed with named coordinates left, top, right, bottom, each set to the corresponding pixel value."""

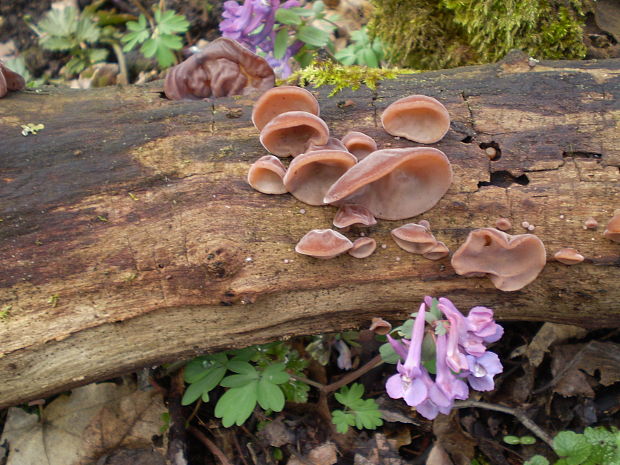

left=219, top=0, right=304, bottom=78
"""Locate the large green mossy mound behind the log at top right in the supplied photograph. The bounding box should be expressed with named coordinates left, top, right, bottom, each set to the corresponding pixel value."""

left=369, top=0, right=592, bottom=69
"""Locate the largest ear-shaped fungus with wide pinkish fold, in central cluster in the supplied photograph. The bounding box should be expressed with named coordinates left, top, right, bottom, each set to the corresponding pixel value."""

left=325, top=147, right=452, bottom=220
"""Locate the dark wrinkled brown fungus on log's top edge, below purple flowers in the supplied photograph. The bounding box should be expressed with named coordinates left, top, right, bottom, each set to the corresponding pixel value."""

left=164, top=37, right=275, bottom=100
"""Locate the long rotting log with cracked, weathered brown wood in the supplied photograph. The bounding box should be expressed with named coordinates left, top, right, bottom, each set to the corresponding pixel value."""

left=0, top=54, right=620, bottom=407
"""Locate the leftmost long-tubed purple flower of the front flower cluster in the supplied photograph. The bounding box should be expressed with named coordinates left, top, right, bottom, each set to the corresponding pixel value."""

left=385, top=304, right=430, bottom=407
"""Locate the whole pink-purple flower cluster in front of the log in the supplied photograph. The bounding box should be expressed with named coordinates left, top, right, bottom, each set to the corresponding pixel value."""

left=385, top=297, right=504, bottom=420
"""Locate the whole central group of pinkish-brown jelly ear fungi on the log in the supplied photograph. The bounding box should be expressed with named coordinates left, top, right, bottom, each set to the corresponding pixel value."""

left=248, top=86, right=560, bottom=291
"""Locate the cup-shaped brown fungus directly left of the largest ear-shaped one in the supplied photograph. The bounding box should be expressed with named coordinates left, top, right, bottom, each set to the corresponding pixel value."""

left=284, top=150, right=357, bottom=205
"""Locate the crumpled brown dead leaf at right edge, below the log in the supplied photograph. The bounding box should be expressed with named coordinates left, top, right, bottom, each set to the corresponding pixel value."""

left=551, top=341, right=620, bottom=397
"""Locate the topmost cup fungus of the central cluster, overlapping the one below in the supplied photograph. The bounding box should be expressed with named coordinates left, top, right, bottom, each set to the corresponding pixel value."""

left=252, top=86, right=320, bottom=131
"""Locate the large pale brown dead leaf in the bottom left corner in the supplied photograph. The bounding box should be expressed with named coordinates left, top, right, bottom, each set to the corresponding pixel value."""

left=0, top=383, right=166, bottom=465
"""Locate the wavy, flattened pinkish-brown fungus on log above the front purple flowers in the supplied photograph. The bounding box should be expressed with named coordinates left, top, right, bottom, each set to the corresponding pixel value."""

left=452, top=228, right=547, bottom=291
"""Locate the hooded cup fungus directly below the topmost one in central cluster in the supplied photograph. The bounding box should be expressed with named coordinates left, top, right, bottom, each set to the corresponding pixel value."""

left=260, top=111, right=329, bottom=157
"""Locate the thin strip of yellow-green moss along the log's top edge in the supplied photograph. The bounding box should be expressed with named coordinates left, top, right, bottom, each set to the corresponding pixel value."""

left=285, top=60, right=416, bottom=97
